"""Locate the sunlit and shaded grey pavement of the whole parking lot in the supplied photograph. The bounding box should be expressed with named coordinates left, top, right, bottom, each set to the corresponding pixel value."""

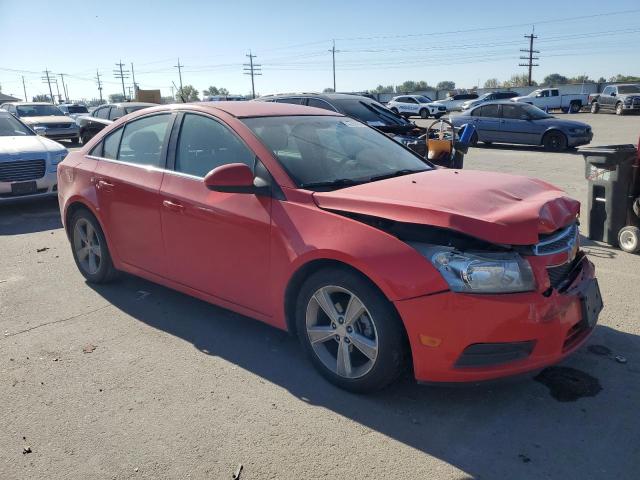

left=0, top=114, right=640, bottom=480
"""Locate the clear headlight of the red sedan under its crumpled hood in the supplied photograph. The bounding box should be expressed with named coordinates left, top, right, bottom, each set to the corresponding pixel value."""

left=411, top=243, right=536, bottom=293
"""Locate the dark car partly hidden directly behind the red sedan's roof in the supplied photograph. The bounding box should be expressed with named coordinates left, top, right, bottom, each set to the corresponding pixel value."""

left=257, top=93, right=426, bottom=155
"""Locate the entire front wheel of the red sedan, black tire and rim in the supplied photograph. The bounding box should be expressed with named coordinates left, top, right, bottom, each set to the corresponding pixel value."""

left=296, top=268, right=406, bottom=393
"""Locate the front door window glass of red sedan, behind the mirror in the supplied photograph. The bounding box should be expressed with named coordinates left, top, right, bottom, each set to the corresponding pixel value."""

left=175, top=113, right=255, bottom=177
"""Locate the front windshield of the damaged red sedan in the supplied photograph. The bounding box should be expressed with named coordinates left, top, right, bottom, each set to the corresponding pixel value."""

left=243, top=116, right=431, bottom=189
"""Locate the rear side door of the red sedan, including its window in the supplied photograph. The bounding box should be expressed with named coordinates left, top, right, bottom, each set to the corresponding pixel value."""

left=95, top=113, right=175, bottom=276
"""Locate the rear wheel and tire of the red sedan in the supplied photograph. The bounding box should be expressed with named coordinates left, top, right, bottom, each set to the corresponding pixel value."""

left=69, top=209, right=118, bottom=283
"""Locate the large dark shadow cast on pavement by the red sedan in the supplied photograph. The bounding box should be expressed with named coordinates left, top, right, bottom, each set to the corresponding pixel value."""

left=91, top=275, right=640, bottom=480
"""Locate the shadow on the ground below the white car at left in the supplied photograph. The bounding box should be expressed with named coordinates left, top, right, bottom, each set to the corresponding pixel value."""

left=0, top=197, right=62, bottom=235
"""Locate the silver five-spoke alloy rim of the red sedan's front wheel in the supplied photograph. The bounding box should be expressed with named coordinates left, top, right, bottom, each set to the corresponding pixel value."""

left=305, top=285, right=378, bottom=379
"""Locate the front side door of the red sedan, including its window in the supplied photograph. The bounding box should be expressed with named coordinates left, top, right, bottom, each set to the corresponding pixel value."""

left=161, top=113, right=272, bottom=314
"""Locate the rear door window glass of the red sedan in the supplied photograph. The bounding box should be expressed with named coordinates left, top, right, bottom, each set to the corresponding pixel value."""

left=117, top=114, right=171, bottom=167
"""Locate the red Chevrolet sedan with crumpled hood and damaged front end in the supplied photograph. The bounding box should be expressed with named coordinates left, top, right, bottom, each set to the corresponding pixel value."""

left=58, top=102, right=602, bottom=391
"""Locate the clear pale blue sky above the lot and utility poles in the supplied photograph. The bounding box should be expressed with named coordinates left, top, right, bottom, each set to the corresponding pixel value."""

left=0, top=0, right=640, bottom=100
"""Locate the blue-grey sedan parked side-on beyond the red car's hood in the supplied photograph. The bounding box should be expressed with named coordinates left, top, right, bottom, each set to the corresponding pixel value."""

left=452, top=101, right=593, bottom=151
